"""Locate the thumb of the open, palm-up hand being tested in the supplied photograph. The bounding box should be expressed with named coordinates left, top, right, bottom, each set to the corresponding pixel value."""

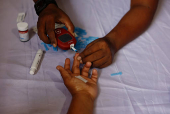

left=56, top=66, right=71, bottom=81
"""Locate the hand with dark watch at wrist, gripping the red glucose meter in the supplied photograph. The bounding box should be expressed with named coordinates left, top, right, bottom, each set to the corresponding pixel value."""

left=37, top=4, right=74, bottom=47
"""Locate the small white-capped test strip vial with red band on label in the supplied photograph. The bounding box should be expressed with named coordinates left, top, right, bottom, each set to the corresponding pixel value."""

left=17, top=22, right=29, bottom=42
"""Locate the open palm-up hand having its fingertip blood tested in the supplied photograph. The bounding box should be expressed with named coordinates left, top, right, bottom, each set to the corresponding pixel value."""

left=57, top=53, right=98, bottom=100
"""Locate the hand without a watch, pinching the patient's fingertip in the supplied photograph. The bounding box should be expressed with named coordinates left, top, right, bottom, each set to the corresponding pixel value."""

left=77, top=37, right=115, bottom=68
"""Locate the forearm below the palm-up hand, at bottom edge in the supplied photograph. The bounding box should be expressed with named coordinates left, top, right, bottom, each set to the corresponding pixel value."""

left=67, top=95, right=94, bottom=114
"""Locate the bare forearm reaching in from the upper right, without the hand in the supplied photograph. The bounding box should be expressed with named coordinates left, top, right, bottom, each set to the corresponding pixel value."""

left=106, top=5, right=159, bottom=51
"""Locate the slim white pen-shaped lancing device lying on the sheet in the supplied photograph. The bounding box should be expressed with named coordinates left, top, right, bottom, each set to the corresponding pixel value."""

left=30, top=49, right=43, bottom=75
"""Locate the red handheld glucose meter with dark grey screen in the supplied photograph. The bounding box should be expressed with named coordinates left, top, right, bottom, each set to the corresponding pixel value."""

left=55, top=28, right=77, bottom=50
